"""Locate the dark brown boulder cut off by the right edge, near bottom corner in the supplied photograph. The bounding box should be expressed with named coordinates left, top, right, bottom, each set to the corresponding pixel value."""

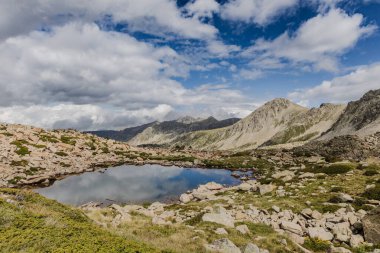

left=362, top=207, right=380, bottom=244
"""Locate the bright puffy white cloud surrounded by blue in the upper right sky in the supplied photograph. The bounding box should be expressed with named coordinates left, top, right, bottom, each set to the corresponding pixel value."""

left=243, top=9, right=376, bottom=71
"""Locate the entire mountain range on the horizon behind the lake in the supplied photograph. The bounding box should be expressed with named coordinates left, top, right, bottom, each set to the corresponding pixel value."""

left=92, top=90, right=380, bottom=150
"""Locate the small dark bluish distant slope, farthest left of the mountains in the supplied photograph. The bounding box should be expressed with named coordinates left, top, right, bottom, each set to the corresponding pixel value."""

left=88, top=122, right=156, bottom=141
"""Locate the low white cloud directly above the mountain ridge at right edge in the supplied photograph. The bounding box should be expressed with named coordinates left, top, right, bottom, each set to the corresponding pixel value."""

left=289, top=63, right=380, bottom=105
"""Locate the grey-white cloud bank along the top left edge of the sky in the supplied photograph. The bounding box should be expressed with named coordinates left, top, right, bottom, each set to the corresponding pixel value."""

left=0, top=0, right=218, bottom=39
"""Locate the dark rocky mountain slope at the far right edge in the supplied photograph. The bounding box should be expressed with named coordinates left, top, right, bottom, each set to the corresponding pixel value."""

left=321, top=89, right=380, bottom=140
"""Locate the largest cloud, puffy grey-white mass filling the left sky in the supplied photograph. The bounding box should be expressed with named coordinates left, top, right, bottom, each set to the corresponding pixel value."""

left=0, top=22, right=245, bottom=129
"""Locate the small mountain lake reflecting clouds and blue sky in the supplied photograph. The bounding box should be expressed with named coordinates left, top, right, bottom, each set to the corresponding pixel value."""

left=35, top=165, right=239, bottom=205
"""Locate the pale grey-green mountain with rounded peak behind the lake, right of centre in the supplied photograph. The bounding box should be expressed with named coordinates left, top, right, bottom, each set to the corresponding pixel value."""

left=168, top=98, right=345, bottom=150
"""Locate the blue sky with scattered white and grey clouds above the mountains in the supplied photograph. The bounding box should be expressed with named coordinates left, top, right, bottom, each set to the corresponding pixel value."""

left=0, top=0, right=380, bottom=130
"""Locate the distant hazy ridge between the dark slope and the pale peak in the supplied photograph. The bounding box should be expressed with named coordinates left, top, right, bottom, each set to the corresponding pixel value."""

left=129, top=117, right=239, bottom=146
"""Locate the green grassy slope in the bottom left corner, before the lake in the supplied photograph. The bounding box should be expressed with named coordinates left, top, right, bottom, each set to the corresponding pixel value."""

left=0, top=189, right=158, bottom=253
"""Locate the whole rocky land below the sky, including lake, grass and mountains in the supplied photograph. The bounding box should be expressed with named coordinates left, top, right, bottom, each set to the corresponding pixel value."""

left=0, top=90, right=380, bottom=253
